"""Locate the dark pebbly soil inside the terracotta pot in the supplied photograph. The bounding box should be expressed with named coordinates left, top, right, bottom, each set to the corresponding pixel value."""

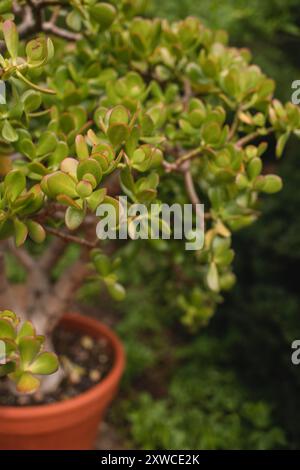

left=0, top=326, right=114, bottom=406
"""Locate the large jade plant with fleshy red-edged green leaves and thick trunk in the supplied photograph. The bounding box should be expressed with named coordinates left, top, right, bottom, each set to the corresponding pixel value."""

left=0, top=0, right=300, bottom=392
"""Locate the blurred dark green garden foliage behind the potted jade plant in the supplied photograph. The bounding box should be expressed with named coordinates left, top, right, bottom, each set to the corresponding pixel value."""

left=96, top=0, right=300, bottom=449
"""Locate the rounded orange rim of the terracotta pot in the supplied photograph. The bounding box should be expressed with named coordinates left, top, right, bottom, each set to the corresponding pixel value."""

left=0, top=312, right=125, bottom=419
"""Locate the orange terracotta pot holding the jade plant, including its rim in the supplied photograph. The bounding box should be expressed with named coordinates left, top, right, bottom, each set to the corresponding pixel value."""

left=0, top=313, right=125, bottom=450
